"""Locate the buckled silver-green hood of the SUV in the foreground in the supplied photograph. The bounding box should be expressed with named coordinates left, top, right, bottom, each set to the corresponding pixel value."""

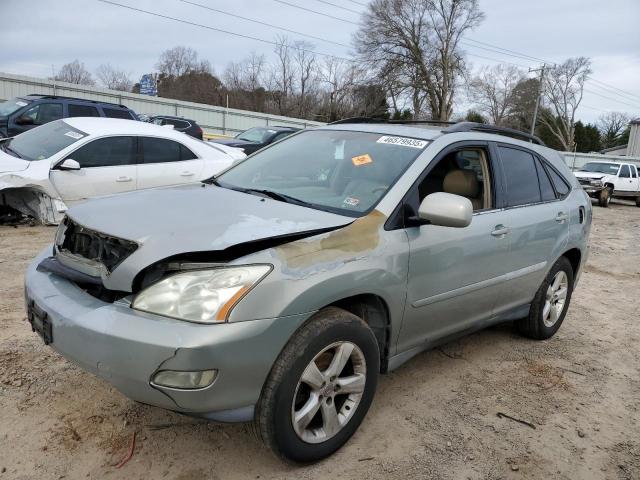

left=68, top=184, right=354, bottom=291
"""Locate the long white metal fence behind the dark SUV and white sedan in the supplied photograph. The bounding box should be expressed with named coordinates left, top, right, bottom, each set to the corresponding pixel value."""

left=0, top=72, right=324, bottom=135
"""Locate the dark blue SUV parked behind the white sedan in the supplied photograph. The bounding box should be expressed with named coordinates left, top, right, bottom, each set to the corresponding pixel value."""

left=0, top=95, right=138, bottom=138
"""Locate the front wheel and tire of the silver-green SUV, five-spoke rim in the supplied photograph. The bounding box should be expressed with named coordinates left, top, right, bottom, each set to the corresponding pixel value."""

left=254, top=307, right=380, bottom=463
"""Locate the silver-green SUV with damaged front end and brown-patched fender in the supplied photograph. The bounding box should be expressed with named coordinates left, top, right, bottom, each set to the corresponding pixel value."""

left=25, top=119, right=591, bottom=462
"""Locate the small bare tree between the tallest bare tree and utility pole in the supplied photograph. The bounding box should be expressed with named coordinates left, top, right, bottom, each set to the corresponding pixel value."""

left=469, top=65, right=524, bottom=126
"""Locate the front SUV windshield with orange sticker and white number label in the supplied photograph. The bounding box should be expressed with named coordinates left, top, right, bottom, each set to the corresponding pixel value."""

left=215, top=130, right=429, bottom=217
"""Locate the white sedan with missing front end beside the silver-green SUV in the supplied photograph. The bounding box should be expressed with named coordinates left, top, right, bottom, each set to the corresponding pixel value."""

left=0, top=118, right=245, bottom=223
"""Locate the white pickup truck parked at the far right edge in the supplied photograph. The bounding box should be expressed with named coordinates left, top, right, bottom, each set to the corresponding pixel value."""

left=573, top=160, right=640, bottom=207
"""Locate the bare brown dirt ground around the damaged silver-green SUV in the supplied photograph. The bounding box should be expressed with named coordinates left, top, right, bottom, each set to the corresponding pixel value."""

left=0, top=203, right=640, bottom=480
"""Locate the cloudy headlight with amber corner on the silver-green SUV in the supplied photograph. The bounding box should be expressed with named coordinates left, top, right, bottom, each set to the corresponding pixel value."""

left=131, top=265, right=271, bottom=323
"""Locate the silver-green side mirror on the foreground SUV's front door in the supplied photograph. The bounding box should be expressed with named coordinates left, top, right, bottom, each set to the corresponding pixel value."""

left=418, top=192, right=473, bottom=228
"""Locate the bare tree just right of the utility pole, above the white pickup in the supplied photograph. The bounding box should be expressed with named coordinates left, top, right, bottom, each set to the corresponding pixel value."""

left=540, top=57, right=591, bottom=151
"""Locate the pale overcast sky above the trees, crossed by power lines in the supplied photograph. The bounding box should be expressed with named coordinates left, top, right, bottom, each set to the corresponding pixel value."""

left=0, top=0, right=640, bottom=121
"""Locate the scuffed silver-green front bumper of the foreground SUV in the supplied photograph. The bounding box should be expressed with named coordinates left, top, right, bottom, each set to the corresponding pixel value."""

left=25, top=247, right=311, bottom=421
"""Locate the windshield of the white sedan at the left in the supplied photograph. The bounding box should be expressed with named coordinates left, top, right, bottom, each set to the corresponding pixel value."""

left=2, top=120, right=87, bottom=160
